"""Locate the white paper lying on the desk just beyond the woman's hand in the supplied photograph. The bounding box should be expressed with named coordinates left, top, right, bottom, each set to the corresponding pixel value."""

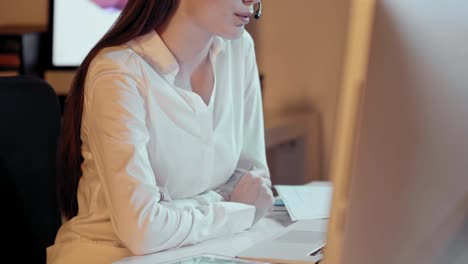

left=274, top=182, right=332, bottom=221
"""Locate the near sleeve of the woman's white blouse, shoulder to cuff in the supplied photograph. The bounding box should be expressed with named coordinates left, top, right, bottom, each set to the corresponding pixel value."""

left=86, top=72, right=252, bottom=255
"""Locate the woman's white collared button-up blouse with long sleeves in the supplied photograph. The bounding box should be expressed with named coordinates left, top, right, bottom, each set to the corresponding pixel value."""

left=47, top=31, right=268, bottom=263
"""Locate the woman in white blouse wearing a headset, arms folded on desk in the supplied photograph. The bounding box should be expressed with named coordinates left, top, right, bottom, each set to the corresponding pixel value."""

left=48, top=0, right=273, bottom=263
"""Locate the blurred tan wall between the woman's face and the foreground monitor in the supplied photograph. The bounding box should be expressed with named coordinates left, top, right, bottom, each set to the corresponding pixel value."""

left=251, top=0, right=349, bottom=177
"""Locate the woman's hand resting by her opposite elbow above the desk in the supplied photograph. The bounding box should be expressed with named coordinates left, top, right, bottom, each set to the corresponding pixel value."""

left=231, top=170, right=275, bottom=224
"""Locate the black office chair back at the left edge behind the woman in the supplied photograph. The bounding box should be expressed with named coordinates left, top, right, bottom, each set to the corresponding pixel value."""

left=0, top=76, right=61, bottom=263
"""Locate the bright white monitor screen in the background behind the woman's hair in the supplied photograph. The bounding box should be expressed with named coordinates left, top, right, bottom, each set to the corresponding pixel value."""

left=52, top=0, right=127, bottom=67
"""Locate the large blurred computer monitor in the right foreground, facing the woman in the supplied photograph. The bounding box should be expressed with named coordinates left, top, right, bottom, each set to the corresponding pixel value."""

left=324, top=0, right=468, bottom=264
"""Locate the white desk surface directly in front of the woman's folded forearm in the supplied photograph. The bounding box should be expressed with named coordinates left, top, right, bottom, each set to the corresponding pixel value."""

left=115, top=212, right=326, bottom=264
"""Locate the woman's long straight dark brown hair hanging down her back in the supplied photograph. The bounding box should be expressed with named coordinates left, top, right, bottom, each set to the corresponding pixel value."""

left=57, top=0, right=177, bottom=219
